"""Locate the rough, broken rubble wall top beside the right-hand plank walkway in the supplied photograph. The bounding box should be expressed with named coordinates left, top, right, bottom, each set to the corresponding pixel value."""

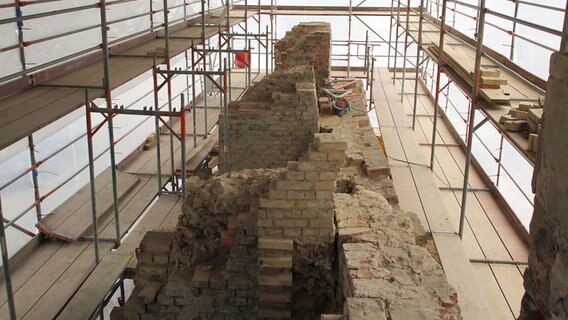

left=322, top=85, right=461, bottom=320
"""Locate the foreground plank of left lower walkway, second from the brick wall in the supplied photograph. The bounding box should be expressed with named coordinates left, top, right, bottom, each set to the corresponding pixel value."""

left=23, top=242, right=114, bottom=320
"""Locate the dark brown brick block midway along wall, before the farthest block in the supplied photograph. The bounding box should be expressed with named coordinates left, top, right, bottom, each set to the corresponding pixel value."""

left=219, top=66, right=319, bottom=170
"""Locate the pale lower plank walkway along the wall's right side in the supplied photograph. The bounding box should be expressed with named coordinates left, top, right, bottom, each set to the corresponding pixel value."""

left=373, top=69, right=528, bottom=320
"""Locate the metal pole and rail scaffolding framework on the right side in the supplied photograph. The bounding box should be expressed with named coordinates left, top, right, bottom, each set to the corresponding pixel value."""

left=388, top=0, right=564, bottom=245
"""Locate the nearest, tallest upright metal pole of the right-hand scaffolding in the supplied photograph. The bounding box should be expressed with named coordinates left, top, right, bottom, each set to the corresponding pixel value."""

left=459, top=0, right=486, bottom=239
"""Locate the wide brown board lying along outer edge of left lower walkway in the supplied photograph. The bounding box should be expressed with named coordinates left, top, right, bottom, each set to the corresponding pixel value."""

left=38, top=174, right=140, bottom=242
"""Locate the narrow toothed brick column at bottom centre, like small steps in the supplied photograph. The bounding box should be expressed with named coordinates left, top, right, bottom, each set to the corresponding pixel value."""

left=257, top=238, right=294, bottom=319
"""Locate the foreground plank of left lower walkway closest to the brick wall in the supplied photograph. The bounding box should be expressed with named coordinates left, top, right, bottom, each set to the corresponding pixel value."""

left=57, top=253, right=131, bottom=320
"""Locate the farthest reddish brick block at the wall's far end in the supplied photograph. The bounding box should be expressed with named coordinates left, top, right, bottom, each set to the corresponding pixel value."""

left=274, top=22, right=331, bottom=87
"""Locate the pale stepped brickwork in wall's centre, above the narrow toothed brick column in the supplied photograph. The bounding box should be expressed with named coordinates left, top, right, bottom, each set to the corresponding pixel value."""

left=258, top=133, right=347, bottom=244
